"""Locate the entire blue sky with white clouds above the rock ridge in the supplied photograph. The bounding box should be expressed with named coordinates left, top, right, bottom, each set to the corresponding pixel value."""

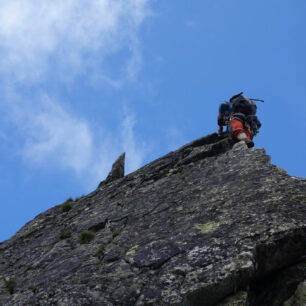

left=0, top=0, right=306, bottom=241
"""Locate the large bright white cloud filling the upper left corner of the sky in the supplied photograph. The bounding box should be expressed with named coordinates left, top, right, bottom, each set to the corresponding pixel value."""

left=0, top=0, right=150, bottom=84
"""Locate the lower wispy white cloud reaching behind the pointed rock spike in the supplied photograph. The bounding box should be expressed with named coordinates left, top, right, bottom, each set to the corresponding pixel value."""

left=9, top=96, right=145, bottom=187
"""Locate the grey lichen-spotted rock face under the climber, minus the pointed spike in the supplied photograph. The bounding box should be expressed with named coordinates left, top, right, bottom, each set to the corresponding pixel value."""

left=0, top=134, right=306, bottom=306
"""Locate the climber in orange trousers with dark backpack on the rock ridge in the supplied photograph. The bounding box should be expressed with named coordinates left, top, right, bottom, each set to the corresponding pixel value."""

left=218, top=92, right=263, bottom=148
